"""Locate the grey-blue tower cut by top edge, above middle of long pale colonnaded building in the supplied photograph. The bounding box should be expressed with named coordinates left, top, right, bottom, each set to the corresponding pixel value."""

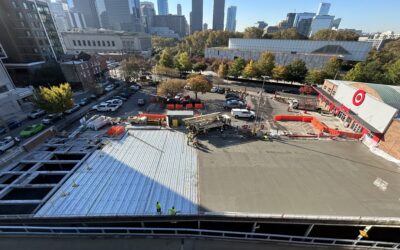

left=104, top=0, right=134, bottom=31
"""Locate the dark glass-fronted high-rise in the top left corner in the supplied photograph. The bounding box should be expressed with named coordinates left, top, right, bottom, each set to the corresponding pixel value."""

left=0, top=0, right=64, bottom=85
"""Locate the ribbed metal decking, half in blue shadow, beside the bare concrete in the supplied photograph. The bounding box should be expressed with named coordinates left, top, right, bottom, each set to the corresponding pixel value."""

left=35, top=130, right=198, bottom=217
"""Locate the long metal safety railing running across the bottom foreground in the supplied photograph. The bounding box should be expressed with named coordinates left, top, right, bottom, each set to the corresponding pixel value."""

left=0, top=226, right=400, bottom=249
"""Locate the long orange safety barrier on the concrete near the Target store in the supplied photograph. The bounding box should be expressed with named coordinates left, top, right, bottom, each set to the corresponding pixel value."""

left=274, top=115, right=363, bottom=139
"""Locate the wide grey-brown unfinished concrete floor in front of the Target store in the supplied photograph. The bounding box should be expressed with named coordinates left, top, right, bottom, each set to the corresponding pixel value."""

left=199, top=135, right=400, bottom=217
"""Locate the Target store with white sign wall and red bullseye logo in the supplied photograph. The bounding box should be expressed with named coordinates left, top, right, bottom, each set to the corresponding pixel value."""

left=314, top=80, right=400, bottom=158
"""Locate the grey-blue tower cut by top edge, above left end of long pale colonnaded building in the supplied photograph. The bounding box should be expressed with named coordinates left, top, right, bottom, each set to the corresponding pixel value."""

left=74, top=0, right=100, bottom=29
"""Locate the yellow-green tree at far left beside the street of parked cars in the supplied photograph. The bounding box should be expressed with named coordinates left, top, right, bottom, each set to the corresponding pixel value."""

left=34, top=83, right=74, bottom=113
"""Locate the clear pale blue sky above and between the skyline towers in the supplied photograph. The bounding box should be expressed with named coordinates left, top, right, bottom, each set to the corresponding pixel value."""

left=146, top=0, right=400, bottom=33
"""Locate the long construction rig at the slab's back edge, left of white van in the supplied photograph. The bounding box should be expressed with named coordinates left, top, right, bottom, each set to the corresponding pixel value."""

left=182, top=113, right=231, bottom=134
